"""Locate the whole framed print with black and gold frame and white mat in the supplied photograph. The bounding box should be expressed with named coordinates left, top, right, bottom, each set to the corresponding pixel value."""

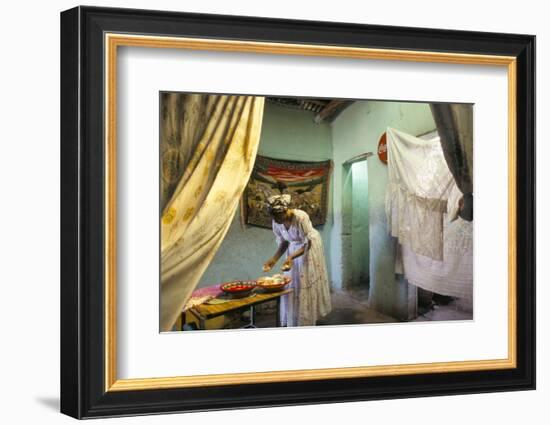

left=61, top=7, right=535, bottom=418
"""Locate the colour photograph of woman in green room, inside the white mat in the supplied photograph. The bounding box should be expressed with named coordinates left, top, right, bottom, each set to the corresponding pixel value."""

left=159, top=91, right=475, bottom=332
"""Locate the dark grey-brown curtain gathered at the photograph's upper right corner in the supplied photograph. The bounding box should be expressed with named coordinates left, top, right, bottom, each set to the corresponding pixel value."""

left=430, top=103, right=474, bottom=221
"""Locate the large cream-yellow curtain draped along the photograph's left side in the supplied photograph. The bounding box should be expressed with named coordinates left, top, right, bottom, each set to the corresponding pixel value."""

left=160, top=93, right=264, bottom=331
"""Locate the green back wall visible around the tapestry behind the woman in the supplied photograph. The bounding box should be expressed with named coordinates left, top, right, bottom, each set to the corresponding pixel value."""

left=198, top=102, right=332, bottom=287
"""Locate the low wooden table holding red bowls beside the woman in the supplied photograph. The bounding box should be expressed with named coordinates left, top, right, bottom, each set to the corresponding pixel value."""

left=181, top=289, right=293, bottom=330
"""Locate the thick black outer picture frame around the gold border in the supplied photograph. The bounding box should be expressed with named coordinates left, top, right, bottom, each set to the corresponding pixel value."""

left=61, top=7, right=535, bottom=418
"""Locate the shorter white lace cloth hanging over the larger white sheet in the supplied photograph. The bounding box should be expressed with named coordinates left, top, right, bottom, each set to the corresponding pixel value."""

left=386, top=128, right=454, bottom=260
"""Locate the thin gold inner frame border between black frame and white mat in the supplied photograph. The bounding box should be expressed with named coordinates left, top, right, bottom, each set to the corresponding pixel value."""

left=104, top=33, right=517, bottom=391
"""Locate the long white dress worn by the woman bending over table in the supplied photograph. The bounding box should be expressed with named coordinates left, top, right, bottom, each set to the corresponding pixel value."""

left=272, top=209, right=331, bottom=326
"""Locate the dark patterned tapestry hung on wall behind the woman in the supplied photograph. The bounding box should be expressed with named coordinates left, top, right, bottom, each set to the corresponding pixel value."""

left=242, top=155, right=332, bottom=229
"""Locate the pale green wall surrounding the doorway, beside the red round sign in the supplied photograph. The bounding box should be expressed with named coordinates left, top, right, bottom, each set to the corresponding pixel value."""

left=330, top=101, right=435, bottom=319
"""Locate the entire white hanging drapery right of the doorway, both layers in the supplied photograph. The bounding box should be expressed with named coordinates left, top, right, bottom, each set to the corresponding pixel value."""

left=386, top=128, right=473, bottom=300
